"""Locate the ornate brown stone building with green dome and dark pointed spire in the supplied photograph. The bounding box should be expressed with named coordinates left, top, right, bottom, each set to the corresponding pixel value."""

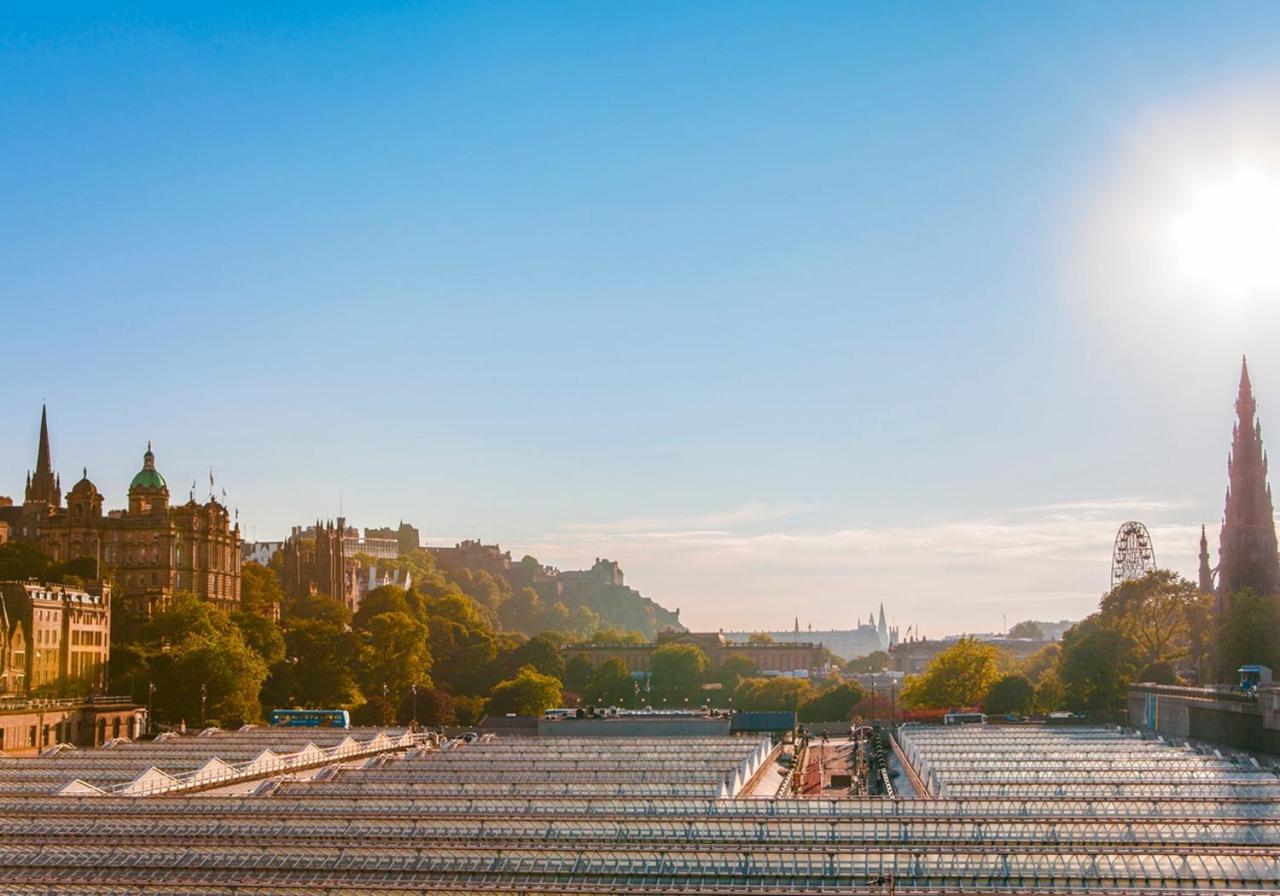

left=8, top=416, right=241, bottom=616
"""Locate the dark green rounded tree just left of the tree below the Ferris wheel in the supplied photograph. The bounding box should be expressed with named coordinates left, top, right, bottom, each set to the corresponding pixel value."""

left=1057, top=613, right=1135, bottom=712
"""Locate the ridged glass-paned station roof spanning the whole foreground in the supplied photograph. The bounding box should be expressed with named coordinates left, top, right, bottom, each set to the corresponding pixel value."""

left=0, top=724, right=1280, bottom=896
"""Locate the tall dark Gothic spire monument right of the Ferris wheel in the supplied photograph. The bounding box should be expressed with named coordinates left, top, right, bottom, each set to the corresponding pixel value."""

left=1217, top=361, right=1280, bottom=611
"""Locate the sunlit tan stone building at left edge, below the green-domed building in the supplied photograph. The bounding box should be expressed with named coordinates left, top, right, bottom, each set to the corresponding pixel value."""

left=0, top=581, right=111, bottom=696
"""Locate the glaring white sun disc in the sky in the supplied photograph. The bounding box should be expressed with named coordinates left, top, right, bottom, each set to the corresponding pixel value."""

left=1158, top=163, right=1280, bottom=300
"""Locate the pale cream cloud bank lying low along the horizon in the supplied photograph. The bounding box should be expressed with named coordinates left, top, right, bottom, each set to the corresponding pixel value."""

left=520, top=498, right=1199, bottom=635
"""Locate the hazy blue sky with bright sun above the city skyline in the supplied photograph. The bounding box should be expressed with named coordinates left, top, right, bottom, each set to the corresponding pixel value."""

left=0, top=3, right=1280, bottom=635
